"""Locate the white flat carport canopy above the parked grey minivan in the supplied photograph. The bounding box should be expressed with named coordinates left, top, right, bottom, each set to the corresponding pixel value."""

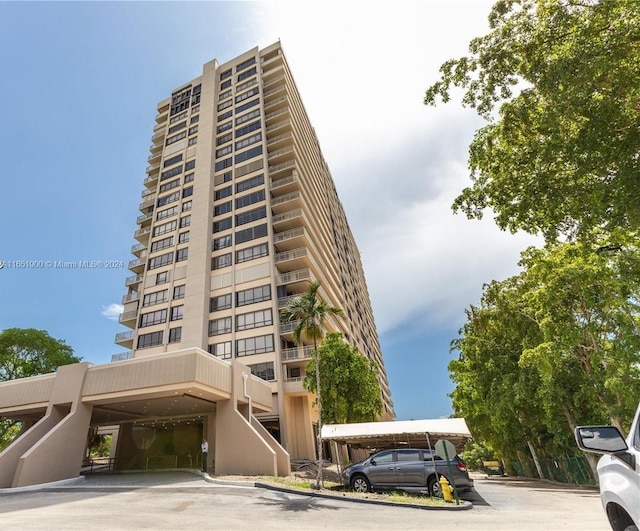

left=321, top=419, right=471, bottom=452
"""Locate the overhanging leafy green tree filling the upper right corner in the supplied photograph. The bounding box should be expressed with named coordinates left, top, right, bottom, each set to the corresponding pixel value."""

left=424, top=0, right=640, bottom=241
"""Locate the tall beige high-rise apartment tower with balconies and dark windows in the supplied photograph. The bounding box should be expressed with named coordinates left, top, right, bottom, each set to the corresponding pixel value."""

left=116, top=43, right=394, bottom=459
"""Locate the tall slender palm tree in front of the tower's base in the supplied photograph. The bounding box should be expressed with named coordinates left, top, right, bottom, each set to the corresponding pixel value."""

left=281, top=280, right=343, bottom=489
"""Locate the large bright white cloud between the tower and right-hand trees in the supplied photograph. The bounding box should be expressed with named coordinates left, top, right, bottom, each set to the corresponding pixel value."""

left=252, top=0, right=539, bottom=332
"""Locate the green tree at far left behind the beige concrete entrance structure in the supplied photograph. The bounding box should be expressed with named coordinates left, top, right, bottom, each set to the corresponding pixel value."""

left=0, top=328, right=81, bottom=450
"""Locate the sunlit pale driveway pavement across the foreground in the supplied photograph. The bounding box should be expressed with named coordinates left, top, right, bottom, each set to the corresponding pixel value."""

left=0, top=472, right=609, bottom=531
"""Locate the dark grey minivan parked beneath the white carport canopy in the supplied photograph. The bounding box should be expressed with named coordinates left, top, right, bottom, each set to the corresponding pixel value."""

left=342, top=448, right=473, bottom=496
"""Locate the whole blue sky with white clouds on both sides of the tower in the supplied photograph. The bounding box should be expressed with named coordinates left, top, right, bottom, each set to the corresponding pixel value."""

left=0, top=0, right=535, bottom=419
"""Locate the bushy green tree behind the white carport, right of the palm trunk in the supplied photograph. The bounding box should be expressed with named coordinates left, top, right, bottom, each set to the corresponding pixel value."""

left=303, top=332, right=383, bottom=424
